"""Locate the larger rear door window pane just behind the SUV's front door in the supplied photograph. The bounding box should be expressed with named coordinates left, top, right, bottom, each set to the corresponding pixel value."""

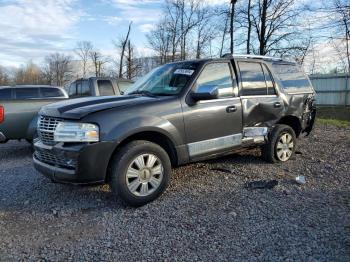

left=238, top=62, right=267, bottom=96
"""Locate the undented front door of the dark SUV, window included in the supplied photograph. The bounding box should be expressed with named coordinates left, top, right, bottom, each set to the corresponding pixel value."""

left=183, top=61, right=242, bottom=160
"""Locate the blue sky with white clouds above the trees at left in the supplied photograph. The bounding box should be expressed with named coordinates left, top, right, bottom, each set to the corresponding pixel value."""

left=0, top=0, right=225, bottom=67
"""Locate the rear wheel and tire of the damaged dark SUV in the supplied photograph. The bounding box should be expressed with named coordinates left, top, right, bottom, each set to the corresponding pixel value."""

left=261, top=125, right=296, bottom=163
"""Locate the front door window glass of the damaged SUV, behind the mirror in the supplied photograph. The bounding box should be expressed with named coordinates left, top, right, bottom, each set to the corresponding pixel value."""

left=195, top=63, right=234, bottom=98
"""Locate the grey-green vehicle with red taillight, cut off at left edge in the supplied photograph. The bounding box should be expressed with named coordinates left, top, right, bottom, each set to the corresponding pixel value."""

left=0, top=85, right=68, bottom=143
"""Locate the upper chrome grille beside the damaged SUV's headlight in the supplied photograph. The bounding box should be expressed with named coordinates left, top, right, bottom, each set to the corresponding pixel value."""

left=38, top=116, right=61, bottom=146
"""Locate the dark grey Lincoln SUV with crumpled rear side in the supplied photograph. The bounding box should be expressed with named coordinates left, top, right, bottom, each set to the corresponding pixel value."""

left=33, top=56, right=316, bottom=206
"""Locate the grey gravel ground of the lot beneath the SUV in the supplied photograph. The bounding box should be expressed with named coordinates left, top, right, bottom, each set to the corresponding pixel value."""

left=0, top=126, right=350, bottom=261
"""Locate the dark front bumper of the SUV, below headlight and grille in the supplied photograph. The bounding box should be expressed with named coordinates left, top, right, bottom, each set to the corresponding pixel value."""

left=33, top=140, right=115, bottom=184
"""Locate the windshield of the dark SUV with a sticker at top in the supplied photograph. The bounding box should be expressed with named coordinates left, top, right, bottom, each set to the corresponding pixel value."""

left=127, top=62, right=198, bottom=95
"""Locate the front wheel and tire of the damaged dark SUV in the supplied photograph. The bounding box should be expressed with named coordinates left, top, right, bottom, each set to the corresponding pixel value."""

left=109, top=140, right=171, bottom=207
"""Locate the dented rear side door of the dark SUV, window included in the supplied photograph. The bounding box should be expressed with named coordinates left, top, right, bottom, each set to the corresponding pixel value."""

left=237, top=61, right=284, bottom=127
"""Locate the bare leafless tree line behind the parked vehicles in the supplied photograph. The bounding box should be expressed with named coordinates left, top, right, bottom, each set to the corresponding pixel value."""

left=0, top=0, right=350, bottom=86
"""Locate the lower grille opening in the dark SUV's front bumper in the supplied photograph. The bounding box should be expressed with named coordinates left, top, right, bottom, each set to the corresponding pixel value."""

left=34, top=149, right=77, bottom=169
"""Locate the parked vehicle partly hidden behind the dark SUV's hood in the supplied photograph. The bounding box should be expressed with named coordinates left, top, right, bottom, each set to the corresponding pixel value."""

left=66, top=77, right=133, bottom=98
